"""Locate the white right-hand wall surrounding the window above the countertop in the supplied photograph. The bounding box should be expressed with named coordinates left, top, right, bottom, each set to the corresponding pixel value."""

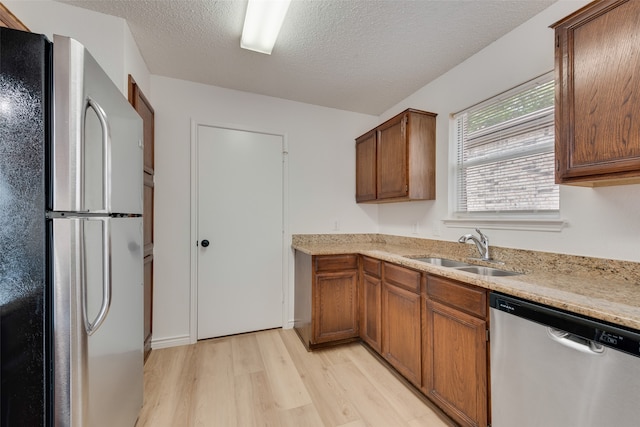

left=378, top=0, right=640, bottom=261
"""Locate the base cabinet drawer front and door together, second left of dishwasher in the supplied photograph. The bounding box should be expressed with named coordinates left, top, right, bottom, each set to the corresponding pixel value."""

left=382, top=262, right=422, bottom=387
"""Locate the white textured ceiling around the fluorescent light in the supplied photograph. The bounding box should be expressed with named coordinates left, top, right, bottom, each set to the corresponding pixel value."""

left=58, top=0, right=557, bottom=115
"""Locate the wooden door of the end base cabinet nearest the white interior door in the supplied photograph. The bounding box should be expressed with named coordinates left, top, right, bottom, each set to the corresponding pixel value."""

left=313, top=270, right=358, bottom=344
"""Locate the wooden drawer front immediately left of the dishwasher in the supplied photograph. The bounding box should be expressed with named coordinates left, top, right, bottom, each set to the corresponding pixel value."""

left=427, top=276, right=487, bottom=319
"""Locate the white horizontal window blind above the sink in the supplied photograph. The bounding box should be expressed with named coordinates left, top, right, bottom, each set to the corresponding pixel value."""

left=454, top=73, right=560, bottom=215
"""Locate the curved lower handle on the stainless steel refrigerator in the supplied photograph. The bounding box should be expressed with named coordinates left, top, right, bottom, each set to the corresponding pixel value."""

left=80, top=220, right=112, bottom=335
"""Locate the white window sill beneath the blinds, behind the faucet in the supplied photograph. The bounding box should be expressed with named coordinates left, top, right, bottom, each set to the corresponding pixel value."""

left=442, top=217, right=568, bottom=232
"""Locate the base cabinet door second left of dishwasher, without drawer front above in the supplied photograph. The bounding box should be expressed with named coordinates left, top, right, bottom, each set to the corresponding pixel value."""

left=382, top=282, right=422, bottom=387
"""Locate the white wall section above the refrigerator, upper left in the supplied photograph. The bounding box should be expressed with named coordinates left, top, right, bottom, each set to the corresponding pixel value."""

left=2, top=0, right=149, bottom=96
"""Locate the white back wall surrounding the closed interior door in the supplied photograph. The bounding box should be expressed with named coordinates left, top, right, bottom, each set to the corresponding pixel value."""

left=151, top=75, right=378, bottom=348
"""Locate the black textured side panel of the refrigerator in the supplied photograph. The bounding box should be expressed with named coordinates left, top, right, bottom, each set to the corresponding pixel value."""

left=0, top=28, right=51, bottom=427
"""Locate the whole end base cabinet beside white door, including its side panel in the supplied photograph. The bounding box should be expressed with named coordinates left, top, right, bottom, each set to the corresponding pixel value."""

left=294, top=251, right=359, bottom=348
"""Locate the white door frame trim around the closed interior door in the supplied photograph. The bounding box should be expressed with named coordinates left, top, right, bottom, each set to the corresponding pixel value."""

left=189, top=119, right=291, bottom=344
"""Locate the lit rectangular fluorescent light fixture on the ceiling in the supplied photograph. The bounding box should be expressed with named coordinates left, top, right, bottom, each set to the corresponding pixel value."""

left=240, top=0, right=291, bottom=55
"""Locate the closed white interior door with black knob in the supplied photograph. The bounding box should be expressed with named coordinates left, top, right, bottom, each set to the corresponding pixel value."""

left=197, top=125, right=283, bottom=339
